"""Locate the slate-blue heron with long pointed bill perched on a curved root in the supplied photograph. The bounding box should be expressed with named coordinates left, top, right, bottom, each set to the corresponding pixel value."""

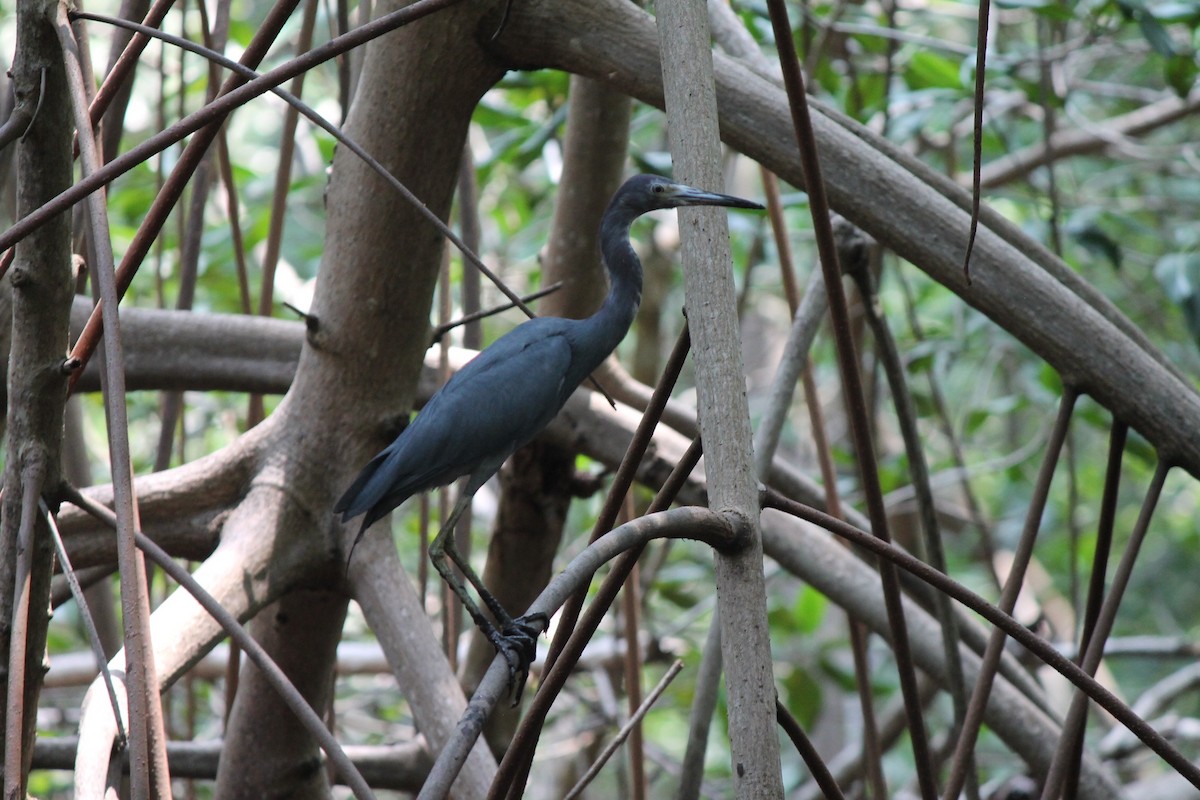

left=334, top=175, right=762, bottom=680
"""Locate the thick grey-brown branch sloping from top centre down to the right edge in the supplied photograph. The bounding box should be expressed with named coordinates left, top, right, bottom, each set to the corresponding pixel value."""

left=492, top=0, right=1200, bottom=476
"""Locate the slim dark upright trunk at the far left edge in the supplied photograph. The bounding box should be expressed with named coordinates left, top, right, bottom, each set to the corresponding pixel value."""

left=0, top=0, right=74, bottom=796
